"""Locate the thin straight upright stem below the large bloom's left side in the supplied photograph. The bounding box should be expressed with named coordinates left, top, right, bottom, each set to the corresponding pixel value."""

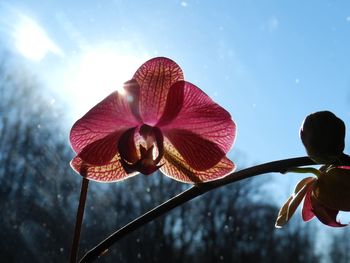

left=69, top=177, right=89, bottom=263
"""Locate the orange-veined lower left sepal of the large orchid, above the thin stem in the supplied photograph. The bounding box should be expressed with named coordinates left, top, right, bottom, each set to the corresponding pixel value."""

left=71, top=155, right=138, bottom=182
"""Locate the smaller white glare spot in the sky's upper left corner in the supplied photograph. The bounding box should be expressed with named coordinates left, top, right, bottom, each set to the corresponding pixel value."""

left=12, top=15, right=62, bottom=61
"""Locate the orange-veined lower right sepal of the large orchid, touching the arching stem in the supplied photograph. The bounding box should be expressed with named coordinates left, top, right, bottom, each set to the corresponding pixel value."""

left=160, top=141, right=235, bottom=183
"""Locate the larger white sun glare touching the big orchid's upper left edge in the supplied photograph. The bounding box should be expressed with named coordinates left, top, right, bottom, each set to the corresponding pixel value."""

left=66, top=47, right=145, bottom=116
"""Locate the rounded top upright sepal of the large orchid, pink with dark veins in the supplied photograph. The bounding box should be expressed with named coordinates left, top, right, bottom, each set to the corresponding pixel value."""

left=133, top=57, right=183, bottom=125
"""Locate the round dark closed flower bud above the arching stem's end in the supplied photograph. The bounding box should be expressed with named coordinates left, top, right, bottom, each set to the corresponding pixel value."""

left=300, top=111, right=345, bottom=164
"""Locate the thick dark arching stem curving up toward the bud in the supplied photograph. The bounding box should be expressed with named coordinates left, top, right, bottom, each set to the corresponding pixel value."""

left=79, top=157, right=315, bottom=263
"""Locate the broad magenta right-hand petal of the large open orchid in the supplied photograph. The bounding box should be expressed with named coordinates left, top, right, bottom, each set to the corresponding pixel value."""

left=157, top=81, right=236, bottom=171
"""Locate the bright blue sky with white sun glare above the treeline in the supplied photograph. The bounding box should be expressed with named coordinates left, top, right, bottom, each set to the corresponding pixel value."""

left=0, top=0, right=350, bottom=235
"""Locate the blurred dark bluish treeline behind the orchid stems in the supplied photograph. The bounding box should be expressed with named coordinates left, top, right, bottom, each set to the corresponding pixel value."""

left=0, top=54, right=319, bottom=263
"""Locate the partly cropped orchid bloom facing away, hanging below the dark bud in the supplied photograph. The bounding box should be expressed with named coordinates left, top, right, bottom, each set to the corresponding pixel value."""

left=276, top=165, right=350, bottom=227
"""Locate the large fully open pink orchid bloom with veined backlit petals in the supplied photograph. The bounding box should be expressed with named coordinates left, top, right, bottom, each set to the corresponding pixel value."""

left=70, top=57, right=236, bottom=183
